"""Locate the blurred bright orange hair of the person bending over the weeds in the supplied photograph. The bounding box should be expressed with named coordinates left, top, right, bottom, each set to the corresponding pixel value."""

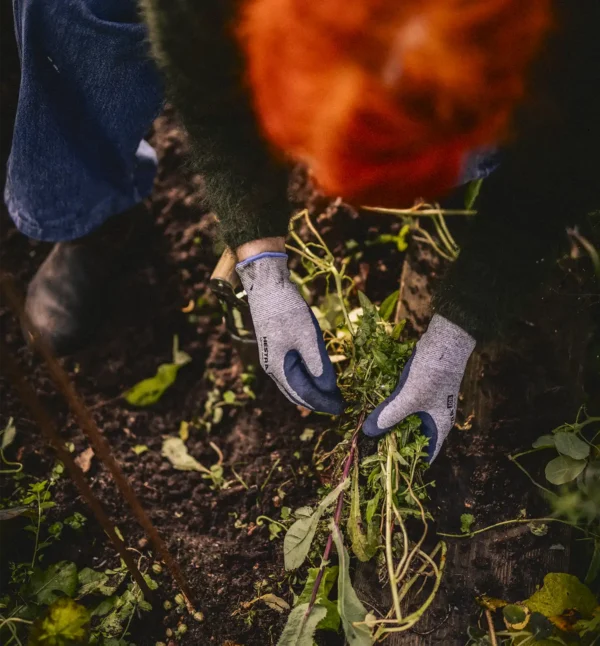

left=240, top=0, right=551, bottom=206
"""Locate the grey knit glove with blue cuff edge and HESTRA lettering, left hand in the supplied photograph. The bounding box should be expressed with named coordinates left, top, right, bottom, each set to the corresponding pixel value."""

left=237, top=251, right=344, bottom=415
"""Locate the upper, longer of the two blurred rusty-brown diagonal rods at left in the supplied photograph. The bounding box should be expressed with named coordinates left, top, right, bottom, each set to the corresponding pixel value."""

left=0, top=272, right=193, bottom=610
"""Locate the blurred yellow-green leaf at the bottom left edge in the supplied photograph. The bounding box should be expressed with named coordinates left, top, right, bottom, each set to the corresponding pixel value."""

left=29, top=597, right=90, bottom=646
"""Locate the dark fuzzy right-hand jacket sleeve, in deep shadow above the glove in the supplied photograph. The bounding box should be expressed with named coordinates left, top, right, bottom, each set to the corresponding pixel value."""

left=434, top=0, right=600, bottom=340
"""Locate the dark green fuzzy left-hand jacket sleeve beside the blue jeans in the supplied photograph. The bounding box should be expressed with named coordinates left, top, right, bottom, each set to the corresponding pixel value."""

left=141, top=0, right=291, bottom=248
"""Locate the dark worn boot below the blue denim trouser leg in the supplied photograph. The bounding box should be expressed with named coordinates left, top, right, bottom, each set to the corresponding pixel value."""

left=25, top=205, right=150, bottom=356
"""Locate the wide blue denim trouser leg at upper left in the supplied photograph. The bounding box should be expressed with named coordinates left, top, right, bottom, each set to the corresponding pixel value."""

left=5, top=0, right=163, bottom=241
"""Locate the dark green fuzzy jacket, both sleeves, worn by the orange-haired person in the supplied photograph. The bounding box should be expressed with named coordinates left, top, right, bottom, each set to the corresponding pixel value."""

left=142, top=0, right=600, bottom=340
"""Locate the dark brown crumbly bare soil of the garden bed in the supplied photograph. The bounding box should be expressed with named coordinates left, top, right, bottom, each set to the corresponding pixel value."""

left=0, top=5, right=600, bottom=646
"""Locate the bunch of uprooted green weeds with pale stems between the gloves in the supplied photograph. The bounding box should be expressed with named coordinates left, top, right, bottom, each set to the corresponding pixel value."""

left=268, top=212, right=446, bottom=646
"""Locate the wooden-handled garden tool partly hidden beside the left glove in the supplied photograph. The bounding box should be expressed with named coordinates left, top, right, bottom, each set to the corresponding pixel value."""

left=209, top=248, right=258, bottom=364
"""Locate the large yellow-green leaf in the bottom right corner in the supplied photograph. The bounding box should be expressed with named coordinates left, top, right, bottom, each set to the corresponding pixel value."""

left=525, top=573, right=598, bottom=619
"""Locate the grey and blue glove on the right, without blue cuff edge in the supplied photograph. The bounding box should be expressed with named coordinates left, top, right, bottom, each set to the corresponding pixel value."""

left=363, top=314, right=475, bottom=462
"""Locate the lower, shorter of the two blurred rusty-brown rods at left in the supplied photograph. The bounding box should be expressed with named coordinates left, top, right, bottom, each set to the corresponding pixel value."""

left=0, top=343, right=152, bottom=599
